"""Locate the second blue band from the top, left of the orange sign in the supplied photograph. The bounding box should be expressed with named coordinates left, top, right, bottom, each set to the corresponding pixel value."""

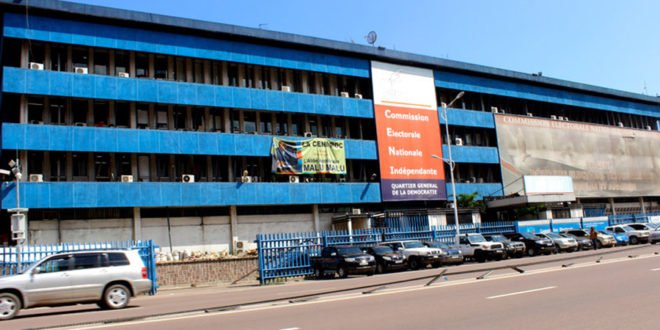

left=2, top=67, right=374, bottom=118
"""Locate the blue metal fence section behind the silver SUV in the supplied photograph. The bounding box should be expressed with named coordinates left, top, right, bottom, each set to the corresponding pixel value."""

left=0, top=240, right=158, bottom=295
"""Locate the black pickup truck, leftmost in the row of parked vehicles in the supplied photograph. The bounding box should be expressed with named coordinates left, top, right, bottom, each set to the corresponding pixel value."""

left=309, top=246, right=376, bottom=278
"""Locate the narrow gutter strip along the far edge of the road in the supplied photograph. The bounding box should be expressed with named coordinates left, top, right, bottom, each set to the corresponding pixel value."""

left=27, top=245, right=658, bottom=330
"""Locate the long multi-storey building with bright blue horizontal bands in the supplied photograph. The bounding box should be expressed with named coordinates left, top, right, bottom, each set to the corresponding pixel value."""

left=0, top=0, right=660, bottom=251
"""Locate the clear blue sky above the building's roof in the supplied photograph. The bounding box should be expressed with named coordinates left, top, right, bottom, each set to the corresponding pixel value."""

left=67, top=0, right=660, bottom=96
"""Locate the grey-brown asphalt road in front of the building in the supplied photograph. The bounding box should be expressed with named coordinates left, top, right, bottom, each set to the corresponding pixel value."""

left=5, top=245, right=660, bottom=329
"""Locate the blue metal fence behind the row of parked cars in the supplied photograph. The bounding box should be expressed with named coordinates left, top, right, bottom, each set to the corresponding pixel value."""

left=256, top=222, right=515, bottom=284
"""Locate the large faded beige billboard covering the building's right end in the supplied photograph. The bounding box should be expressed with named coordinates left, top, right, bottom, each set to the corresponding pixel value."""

left=495, top=114, right=660, bottom=198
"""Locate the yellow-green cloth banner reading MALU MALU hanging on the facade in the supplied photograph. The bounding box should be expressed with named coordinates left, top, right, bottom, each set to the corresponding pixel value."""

left=270, top=138, right=346, bottom=174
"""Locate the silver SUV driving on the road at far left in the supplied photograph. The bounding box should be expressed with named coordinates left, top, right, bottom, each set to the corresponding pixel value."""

left=0, top=250, right=152, bottom=320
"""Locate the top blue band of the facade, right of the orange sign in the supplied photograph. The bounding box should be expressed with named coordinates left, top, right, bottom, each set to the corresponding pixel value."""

left=434, top=70, right=660, bottom=117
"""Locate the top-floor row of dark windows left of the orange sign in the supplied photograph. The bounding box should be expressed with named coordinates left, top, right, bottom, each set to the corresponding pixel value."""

left=3, top=39, right=371, bottom=98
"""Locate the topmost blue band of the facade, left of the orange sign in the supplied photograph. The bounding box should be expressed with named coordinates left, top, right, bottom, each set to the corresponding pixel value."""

left=4, top=13, right=370, bottom=78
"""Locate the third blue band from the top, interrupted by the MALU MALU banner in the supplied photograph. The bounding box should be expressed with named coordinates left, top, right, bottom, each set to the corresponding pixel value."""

left=2, top=123, right=377, bottom=159
